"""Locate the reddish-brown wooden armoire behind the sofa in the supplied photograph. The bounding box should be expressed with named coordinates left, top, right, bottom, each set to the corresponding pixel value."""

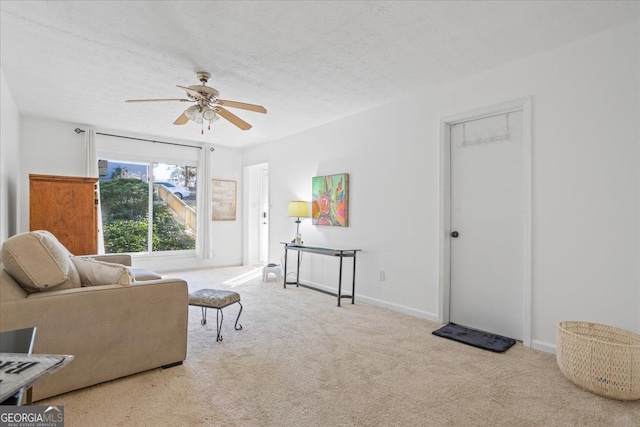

left=29, top=174, right=99, bottom=255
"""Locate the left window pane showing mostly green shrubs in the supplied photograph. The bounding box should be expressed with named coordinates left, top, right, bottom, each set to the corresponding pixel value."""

left=100, top=160, right=149, bottom=254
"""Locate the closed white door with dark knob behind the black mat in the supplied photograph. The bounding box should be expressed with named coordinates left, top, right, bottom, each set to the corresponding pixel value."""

left=449, top=110, right=525, bottom=340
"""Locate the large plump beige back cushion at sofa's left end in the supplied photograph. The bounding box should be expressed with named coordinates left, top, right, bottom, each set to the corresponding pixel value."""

left=2, top=230, right=80, bottom=293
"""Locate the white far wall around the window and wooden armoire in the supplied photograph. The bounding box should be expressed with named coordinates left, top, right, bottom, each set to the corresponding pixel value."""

left=17, top=116, right=242, bottom=272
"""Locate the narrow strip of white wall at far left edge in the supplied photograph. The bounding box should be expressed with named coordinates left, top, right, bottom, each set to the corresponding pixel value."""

left=0, top=69, right=20, bottom=242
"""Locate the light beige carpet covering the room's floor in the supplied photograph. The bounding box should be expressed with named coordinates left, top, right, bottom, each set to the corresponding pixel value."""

left=37, top=267, right=640, bottom=427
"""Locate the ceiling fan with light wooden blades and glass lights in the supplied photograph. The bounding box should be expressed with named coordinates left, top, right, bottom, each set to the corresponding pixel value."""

left=125, top=71, right=267, bottom=133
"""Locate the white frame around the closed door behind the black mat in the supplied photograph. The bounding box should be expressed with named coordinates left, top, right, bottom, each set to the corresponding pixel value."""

left=438, top=96, right=532, bottom=347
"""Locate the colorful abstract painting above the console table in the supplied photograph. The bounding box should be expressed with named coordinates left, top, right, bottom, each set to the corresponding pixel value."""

left=311, top=173, right=349, bottom=227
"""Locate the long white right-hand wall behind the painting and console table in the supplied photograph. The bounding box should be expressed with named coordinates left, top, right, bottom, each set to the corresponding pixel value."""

left=243, top=22, right=640, bottom=351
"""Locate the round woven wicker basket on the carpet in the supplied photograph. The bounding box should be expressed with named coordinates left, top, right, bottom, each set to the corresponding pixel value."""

left=556, top=321, right=640, bottom=400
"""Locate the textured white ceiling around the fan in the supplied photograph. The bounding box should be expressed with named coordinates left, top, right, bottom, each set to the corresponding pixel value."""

left=0, top=1, right=640, bottom=147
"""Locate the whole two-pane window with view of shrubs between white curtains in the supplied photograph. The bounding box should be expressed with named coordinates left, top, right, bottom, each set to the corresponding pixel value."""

left=100, top=159, right=197, bottom=253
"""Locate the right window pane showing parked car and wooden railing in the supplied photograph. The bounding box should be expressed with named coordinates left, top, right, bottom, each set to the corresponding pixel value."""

left=152, top=163, right=197, bottom=252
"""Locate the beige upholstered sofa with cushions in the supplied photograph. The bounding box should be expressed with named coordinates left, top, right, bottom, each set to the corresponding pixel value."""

left=0, top=232, right=188, bottom=401
